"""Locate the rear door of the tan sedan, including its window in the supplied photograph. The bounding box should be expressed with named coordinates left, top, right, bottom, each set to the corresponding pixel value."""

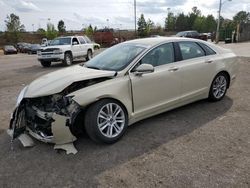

left=177, top=41, right=216, bottom=100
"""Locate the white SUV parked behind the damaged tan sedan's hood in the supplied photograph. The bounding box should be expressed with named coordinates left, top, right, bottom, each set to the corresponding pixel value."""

left=37, top=36, right=94, bottom=67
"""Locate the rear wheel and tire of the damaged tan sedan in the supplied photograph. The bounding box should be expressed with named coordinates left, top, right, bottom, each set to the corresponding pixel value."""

left=208, top=72, right=229, bottom=101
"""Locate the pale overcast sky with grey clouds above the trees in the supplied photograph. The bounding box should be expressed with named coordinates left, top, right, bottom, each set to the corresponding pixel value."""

left=0, top=0, right=250, bottom=31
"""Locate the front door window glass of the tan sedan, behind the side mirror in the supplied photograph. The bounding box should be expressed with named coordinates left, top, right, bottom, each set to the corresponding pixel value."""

left=140, top=43, right=174, bottom=67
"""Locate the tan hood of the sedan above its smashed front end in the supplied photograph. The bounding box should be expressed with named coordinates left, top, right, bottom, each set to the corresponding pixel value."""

left=24, top=65, right=116, bottom=98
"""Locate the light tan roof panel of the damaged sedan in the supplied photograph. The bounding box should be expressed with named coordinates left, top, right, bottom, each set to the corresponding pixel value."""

left=125, top=37, right=202, bottom=48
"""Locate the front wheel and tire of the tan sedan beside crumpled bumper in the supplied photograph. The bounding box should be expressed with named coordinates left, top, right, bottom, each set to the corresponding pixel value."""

left=84, top=99, right=128, bottom=144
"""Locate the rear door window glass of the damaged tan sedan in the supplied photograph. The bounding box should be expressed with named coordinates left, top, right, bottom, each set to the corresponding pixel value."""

left=179, top=41, right=206, bottom=60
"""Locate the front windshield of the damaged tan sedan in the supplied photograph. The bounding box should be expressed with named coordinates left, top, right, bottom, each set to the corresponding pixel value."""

left=85, top=44, right=146, bottom=71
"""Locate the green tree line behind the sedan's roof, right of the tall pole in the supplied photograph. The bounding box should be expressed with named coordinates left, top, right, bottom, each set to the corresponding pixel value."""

left=137, top=7, right=250, bottom=37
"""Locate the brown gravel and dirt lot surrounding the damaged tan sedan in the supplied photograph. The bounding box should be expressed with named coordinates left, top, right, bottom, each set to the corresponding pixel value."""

left=0, top=43, right=250, bottom=188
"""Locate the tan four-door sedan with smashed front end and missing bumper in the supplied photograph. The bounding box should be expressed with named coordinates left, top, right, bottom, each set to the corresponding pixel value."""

left=8, top=37, right=238, bottom=153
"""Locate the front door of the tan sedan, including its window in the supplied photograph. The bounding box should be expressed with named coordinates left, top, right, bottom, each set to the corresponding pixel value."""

left=130, top=43, right=181, bottom=116
